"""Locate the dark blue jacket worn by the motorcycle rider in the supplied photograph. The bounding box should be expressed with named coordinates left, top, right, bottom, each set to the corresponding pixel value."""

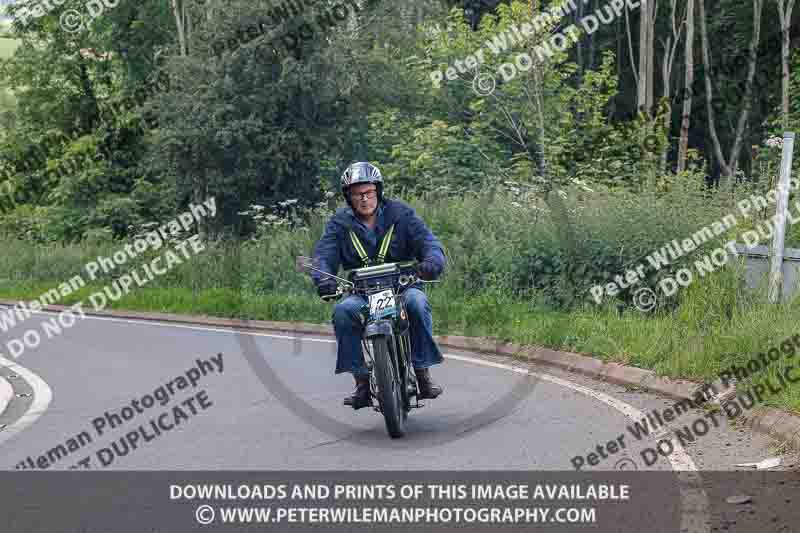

left=311, top=199, right=446, bottom=284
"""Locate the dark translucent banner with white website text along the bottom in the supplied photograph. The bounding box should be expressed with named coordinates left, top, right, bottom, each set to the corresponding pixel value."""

left=0, top=471, right=800, bottom=533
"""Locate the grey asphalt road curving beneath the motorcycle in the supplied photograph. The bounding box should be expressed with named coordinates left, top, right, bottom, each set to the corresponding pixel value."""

left=0, top=314, right=795, bottom=470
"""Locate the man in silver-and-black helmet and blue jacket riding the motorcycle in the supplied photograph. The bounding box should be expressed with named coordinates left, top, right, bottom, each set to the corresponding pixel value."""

left=311, top=162, right=446, bottom=409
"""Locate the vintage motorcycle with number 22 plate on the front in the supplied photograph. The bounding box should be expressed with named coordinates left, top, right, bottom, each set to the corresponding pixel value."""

left=297, top=256, right=438, bottom=438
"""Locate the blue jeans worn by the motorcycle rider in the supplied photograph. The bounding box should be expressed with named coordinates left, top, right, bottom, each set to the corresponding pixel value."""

left=333, top=287, right=444, bottom=376
